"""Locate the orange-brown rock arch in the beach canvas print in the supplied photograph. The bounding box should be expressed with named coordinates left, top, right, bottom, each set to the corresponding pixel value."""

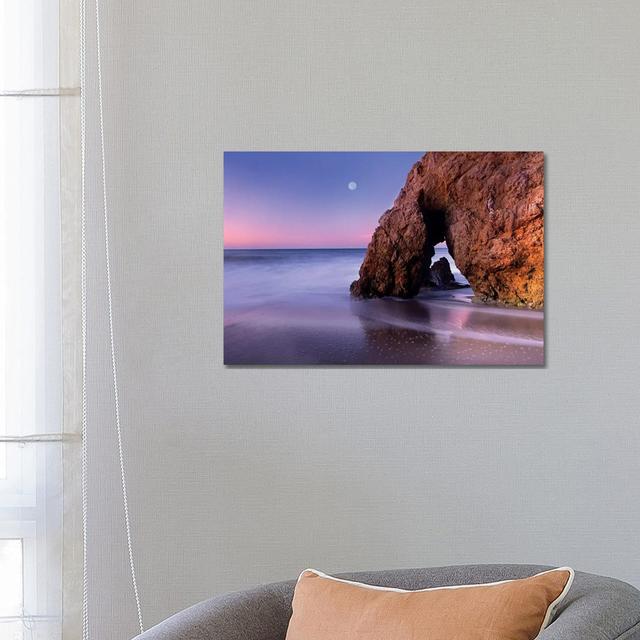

left=351, top=152, right=544, bottom=308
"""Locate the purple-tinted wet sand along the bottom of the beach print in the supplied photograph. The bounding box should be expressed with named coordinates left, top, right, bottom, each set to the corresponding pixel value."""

left=225, top=288, right=544, bottom=366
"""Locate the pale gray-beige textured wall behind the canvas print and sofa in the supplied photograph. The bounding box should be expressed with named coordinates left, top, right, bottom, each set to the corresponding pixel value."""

left=84, top=0, right=640, bottom=640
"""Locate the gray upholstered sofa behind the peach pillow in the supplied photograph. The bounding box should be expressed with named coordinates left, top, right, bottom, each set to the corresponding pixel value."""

left=138, top=565, right=640, bottom=640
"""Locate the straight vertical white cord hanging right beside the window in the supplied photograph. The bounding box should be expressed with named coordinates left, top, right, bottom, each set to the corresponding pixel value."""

left=80, top=0, right=89, bottom=640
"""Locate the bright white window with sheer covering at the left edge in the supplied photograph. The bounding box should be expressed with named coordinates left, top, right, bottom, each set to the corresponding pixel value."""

left=0, top=0, right=79, bottom=640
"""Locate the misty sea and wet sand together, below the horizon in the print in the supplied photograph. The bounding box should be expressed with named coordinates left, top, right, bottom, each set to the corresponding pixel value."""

left=224, top=248, right=544, bottom=366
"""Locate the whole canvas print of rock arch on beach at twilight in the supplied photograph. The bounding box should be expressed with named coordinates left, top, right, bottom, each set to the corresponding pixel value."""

left=224, top=152, right=544, bottom=366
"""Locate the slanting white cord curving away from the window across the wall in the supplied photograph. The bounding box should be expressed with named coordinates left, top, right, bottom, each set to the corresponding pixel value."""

left=96, top=0, right=144, bottom=633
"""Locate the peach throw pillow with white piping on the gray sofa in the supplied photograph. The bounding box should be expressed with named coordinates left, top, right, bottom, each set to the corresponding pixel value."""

left=286, top=567, right=573, bottom=640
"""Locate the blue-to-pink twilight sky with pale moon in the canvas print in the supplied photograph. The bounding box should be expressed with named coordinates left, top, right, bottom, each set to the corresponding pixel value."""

left=224, top=151, right=424, bottom=249
